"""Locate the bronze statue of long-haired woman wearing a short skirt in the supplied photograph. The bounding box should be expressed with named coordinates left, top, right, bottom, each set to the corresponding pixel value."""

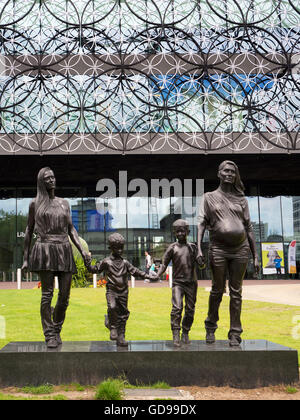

left=22, top=168, right=89, bottom=348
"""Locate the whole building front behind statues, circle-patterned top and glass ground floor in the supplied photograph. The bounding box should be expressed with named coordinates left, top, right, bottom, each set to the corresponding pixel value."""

left=0, top=0, right=300, bottom=280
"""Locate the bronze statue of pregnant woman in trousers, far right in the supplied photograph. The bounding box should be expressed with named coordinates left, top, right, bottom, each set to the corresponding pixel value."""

left=197, top=160, right=259, bottom=346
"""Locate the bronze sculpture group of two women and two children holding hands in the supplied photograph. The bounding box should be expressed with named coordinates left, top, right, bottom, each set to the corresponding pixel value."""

left=22, top=161, right=259, bottom=348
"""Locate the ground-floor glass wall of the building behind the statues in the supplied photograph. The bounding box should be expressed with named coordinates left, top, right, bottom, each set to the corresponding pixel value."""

left=0, top=188, right=300, bottom=281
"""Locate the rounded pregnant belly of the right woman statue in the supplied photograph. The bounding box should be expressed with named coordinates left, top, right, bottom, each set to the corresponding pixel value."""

left=213, top=219, right=247, bottom=247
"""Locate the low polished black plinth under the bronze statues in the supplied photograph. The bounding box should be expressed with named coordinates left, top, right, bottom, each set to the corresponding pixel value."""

left=0, top=340, right=299, bottom=388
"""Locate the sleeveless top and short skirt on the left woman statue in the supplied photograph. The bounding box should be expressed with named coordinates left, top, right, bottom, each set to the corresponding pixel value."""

left=29, top=197, right=77, bottom=274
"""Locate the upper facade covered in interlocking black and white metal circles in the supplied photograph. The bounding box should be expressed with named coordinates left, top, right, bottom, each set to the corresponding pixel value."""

left=0, top=0, right=300, bottom=154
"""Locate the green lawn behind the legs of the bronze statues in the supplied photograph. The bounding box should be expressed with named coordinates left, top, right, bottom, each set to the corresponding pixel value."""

left=0, top=287, right=300, bottom=357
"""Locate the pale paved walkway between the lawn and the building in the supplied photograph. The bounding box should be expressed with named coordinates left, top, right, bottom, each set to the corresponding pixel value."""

left=0, top=280, right=300, bottom=306
